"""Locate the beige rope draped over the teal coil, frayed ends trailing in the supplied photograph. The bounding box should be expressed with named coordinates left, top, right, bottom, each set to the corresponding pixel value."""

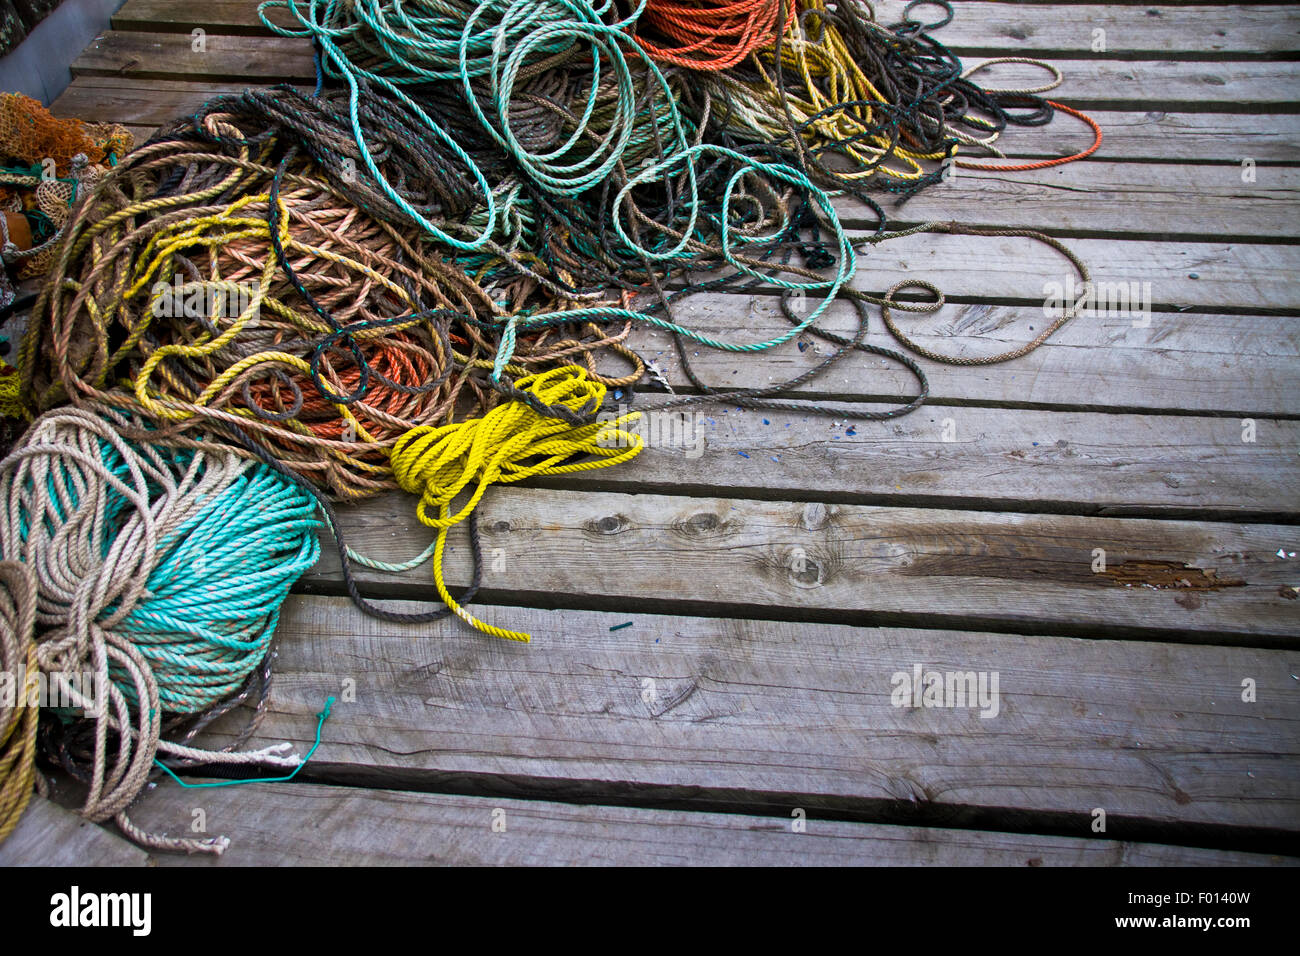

left=0, top=406, right=312, bottom=853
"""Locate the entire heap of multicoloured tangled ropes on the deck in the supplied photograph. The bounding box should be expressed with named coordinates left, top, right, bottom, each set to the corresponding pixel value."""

left=0, top=0, right=1101, bottom=852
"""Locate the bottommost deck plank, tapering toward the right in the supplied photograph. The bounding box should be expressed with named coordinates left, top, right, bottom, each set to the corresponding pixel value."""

left=119, top=784, right=1290, bottom=866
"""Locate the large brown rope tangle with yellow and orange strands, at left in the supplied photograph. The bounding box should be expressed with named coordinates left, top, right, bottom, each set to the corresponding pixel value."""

left=18, top=115, right=490, bottom=497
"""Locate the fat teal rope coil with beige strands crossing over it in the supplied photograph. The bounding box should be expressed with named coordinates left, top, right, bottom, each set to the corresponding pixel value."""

left=0, top=408, right=320, bottom=714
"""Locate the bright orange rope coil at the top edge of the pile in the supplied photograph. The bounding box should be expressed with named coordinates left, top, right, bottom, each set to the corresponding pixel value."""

left=637, top=0, right=794, bottom=72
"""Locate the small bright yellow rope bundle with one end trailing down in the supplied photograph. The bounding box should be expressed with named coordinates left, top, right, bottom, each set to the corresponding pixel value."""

left=391, top=365, right=642, bottom=641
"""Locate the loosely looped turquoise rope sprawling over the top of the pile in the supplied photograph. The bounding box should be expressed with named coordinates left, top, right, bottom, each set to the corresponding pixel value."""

left=259, top=0, right=857, bottom=382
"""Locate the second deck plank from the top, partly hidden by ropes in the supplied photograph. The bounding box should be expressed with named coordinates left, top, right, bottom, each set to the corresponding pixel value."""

left=63, top=45, right=1300, bottom=111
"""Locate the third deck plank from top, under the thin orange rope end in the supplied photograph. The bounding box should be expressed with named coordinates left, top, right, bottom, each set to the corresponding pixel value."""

left=43, top=73, right=1300, bottom=163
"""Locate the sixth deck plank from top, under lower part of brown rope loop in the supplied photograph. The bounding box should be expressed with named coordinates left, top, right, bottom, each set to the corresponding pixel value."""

left=621, top=300, right=1300, bottom=421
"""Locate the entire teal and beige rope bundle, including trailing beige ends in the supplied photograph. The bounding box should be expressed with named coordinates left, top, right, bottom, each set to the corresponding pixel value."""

left=0, top=408, right=320, bottom=852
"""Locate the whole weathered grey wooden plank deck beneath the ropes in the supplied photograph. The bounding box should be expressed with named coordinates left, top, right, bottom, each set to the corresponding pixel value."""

left=0, top=0, right=1300, bottom=866
